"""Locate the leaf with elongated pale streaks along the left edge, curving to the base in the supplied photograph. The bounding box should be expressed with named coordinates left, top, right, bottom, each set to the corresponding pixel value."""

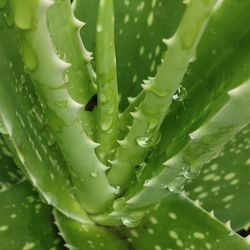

left=0, top=2, right=89, bottom=221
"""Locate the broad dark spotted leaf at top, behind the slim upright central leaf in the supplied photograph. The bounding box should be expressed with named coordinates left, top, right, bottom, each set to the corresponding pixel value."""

left=75, top=0, right=185, bottom=109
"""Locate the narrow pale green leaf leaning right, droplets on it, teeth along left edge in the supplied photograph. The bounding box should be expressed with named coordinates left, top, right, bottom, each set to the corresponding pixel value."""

left=108, top=1, right=215, bottom=189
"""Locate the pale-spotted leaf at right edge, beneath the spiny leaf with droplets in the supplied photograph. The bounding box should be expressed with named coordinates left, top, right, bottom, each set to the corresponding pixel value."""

left=185, top=126, right=250, bottom=229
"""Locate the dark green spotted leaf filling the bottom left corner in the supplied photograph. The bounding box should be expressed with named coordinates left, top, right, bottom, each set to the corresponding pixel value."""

left=0, top=182, right=66, bottom=250
